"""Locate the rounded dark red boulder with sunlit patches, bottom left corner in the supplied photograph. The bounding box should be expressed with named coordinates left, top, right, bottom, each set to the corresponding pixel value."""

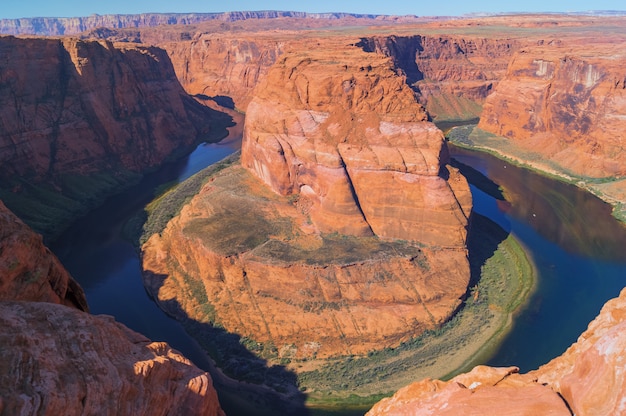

left=0, top=301, right=223, bottom=415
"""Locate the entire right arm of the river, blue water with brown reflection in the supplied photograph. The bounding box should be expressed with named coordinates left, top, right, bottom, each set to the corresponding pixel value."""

left=450, top=146, right=626, bottom=371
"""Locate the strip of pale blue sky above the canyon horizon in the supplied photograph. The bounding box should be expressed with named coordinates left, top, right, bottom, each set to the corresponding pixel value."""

left=0, top=0, right=626, bottom=18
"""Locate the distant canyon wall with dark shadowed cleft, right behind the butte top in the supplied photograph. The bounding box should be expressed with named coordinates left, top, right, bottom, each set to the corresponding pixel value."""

left=359, top=35, right=520, bottom=121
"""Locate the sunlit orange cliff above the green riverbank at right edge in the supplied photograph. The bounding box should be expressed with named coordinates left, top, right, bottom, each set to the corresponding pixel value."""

left=479, top=38, right=626, bottom=177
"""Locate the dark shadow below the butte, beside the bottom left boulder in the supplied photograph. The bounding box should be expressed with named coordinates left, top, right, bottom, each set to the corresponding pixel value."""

left=144, top=272, right=311, bottom=416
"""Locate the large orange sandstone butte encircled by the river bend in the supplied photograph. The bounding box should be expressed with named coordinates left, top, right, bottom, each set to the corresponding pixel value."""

left=143, top=39, right=471, bottom=358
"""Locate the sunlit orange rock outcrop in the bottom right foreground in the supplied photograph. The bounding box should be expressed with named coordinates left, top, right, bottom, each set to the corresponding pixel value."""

left=367, top=289, right=626, bottom=416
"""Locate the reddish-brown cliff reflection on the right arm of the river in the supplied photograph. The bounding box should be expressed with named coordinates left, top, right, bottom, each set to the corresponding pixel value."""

left=451, top=146, right=626, bottom=261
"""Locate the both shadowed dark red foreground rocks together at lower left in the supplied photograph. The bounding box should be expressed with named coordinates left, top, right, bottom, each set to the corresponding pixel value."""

left=0, top=202, right=223, bottom=415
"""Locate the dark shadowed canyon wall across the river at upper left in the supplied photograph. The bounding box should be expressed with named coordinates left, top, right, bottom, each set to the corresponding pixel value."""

left=0, top=37, right=227, bottom=236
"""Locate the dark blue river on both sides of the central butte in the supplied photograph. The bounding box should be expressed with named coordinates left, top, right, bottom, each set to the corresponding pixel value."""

left=51, top=132, right=626, bottom=410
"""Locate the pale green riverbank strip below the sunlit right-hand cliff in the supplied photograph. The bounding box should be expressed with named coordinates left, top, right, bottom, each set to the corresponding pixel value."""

left=446, top=125, right=626, bottom=223
